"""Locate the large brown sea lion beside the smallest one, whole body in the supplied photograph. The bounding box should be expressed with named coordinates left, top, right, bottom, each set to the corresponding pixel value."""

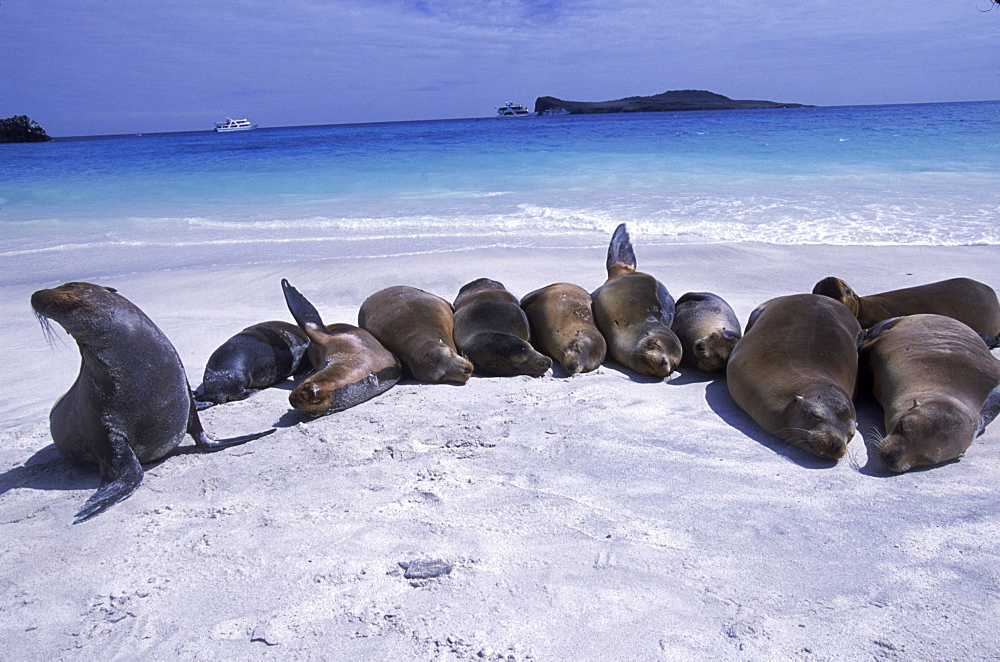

left=726, top=294, right=861, bottom=460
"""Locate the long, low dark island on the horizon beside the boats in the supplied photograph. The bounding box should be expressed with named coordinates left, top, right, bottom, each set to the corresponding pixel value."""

left=535, top=90, right=810, bottom=115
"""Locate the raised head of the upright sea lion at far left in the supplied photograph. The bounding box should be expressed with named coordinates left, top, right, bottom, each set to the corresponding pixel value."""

left=31, top=282, right=121, bottom=340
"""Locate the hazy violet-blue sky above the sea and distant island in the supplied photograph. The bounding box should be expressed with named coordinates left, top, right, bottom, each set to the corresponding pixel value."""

left=0, top=0, right=1000, bottom=136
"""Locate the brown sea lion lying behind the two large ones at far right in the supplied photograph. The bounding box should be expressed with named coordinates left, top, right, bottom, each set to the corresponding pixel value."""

left=813, top=276, right=1000, bottom=338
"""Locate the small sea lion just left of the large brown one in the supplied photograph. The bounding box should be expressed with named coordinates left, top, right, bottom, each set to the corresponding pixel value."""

left=670, top=292, right=741, bottom=372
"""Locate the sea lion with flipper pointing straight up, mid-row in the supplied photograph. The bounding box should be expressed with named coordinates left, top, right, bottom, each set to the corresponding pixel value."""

left=591, top=223, right=682, bottom=377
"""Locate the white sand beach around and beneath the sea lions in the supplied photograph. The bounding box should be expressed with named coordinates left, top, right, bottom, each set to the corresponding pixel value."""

left=0, top=241, right=1000, bottom=662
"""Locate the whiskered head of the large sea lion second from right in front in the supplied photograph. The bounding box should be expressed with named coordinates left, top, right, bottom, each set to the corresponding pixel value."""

left=778, top=385, right=858, bottom=460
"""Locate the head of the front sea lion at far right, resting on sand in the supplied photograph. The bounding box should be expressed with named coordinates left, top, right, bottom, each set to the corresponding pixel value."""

left=876, top=398, right=979, bottom=473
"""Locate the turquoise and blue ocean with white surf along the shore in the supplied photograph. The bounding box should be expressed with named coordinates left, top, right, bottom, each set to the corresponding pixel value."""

left=0, top=102, right=1000, bottom=284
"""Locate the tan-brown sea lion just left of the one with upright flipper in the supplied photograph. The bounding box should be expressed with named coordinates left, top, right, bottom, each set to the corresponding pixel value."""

left=521, top=283, right=608, bottom=375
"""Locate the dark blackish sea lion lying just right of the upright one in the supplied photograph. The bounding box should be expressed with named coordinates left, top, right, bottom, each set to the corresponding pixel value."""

left=194, top=321, right=309, bottom=409
